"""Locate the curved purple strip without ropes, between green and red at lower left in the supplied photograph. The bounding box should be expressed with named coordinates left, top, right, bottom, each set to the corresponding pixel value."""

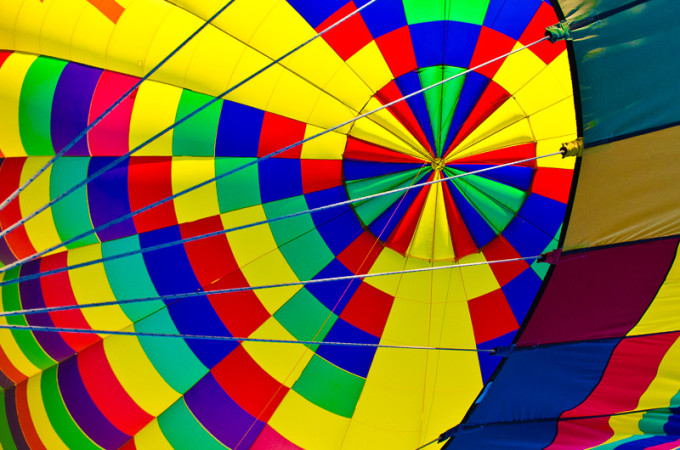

left=57, top=357, right=130, bottom=448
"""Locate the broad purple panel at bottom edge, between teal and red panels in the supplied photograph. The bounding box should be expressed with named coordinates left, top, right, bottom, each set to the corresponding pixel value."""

left=184, top=374, right=265, bottom=448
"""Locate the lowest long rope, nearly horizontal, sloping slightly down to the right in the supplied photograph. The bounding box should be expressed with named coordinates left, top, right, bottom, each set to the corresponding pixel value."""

left=0, top=325, right=492, bottom=353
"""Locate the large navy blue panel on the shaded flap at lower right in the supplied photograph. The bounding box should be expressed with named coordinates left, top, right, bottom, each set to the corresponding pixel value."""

left=466, top=340, right=619, bottom=426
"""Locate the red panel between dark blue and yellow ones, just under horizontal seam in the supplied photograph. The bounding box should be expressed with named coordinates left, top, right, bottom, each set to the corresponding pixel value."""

left=128, top=156, right=177, bottom=233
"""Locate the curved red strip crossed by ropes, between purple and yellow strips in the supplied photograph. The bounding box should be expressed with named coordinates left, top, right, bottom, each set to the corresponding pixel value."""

left=40, top=252, right=100, bottom=353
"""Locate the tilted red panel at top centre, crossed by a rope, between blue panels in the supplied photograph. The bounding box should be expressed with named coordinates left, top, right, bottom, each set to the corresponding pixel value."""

left=316, top=2, right=373, bottom=61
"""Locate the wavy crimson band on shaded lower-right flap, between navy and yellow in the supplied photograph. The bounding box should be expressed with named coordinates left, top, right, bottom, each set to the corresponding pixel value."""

left=548, top=333, right=680, bottom=449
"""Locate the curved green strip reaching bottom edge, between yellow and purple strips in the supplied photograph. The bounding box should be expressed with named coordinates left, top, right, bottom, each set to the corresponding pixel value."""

left=40, top=366, right=100, bottom=450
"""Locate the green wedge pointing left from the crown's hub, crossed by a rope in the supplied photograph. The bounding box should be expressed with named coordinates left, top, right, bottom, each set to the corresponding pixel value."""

left=347, top=169, right=427, bottom=225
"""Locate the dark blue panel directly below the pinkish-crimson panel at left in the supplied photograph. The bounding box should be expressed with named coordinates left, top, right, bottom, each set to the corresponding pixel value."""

left=87, top=157, right=137, bottom=241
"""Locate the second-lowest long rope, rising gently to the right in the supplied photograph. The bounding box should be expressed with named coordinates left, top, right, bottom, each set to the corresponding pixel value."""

left=0, top=256, right=539, bottom=317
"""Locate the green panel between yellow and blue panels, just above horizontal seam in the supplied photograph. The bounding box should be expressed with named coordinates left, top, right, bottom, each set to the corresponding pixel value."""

left=172, top=89, right=222, bottom=156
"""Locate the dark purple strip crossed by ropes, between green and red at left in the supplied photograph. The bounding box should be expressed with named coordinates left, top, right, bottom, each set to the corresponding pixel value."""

left=19, top=260, right=74, bottom=361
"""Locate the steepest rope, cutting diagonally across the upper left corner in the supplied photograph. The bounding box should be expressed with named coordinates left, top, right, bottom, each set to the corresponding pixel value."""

left=0, top=0, right=235, bottom=214
